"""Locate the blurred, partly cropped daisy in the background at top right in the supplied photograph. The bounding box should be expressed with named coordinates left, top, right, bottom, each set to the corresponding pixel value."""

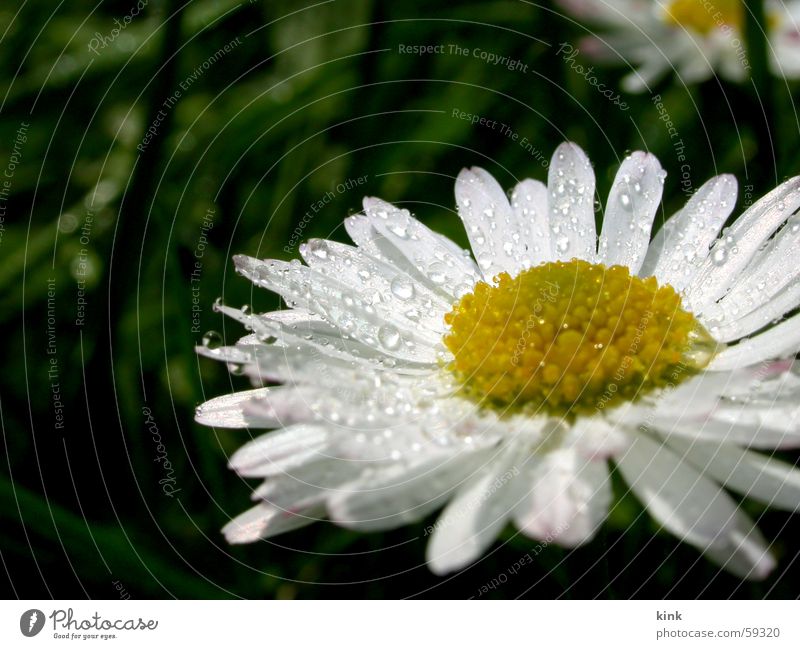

left=559, top=0, right=800, bottom=92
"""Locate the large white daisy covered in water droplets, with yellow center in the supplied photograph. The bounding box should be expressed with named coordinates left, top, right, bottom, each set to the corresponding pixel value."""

left=197, top=143, right=800, bottom=578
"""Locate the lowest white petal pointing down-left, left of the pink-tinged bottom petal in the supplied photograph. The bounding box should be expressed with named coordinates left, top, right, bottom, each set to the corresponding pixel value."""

left=426, top=450, right=527, bottom=575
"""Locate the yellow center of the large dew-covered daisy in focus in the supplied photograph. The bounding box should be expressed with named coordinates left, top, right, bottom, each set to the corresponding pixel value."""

left=444, top=259, right=717, bottom=417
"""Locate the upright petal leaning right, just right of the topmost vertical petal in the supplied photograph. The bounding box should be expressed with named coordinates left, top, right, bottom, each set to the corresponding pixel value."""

left=597, top=151, right=666, bottom=274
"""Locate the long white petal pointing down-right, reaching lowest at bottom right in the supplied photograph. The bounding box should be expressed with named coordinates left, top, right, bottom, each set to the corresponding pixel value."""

left=617, top=435, right=774, bottom=578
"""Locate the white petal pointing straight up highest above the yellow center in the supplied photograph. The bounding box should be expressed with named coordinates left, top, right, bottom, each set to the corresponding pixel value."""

left=547, top=142, right=597, bottom=262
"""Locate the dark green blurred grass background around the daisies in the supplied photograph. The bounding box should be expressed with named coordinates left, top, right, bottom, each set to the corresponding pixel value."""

left=0, top=0, right=800, bottom=598
